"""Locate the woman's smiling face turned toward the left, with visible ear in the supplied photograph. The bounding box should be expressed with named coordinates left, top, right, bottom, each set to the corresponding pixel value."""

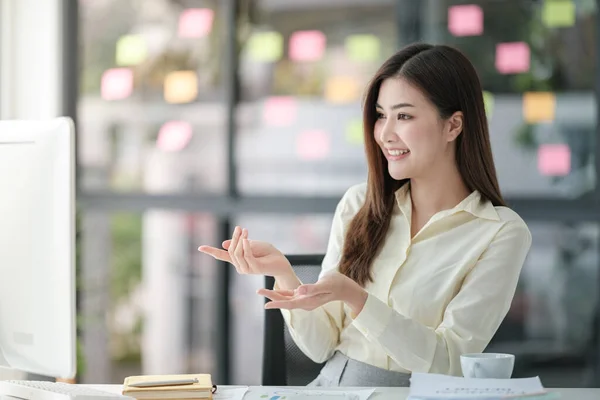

left=374, top=78, right=462, bottom=180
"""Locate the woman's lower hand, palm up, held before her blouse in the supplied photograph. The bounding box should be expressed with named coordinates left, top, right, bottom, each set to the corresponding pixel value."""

left=258, top=272, right=368, bottom=315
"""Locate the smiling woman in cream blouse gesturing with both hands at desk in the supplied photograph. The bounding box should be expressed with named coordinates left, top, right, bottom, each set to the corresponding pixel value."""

left=199, top=44, right=531, bottom=386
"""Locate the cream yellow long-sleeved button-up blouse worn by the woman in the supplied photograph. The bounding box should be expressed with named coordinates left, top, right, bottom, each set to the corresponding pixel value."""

left=282, top=184, right=531, bottom=375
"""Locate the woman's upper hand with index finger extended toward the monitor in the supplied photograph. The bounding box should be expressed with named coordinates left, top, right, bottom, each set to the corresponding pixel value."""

left=198, top=226, right=295, bottom=277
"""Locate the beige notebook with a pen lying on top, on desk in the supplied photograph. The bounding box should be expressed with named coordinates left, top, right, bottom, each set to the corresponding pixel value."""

left=123, top=374, right=213, bottom=400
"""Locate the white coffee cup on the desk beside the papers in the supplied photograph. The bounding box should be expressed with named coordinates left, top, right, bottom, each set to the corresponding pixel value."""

left=460, top=353, right=515, bottom=379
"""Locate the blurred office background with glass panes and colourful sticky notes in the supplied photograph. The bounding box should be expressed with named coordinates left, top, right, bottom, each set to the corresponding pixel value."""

left=0, top=0, right=600, bottom=387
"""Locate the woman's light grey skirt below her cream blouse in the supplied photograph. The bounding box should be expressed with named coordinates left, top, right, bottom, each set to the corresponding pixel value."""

left=308, top=351, right=410, bottom=387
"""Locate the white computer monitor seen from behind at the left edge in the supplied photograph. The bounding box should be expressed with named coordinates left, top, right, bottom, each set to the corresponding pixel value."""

left=0, top=118, right=76, bottom=378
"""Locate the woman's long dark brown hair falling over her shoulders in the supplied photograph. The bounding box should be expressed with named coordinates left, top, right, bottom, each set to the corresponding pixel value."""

left=339, top=43, right=505, bottom=286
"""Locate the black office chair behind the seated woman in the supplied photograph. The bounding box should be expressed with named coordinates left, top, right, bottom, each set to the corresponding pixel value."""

left=262, top=255, right=324, bottom=386
